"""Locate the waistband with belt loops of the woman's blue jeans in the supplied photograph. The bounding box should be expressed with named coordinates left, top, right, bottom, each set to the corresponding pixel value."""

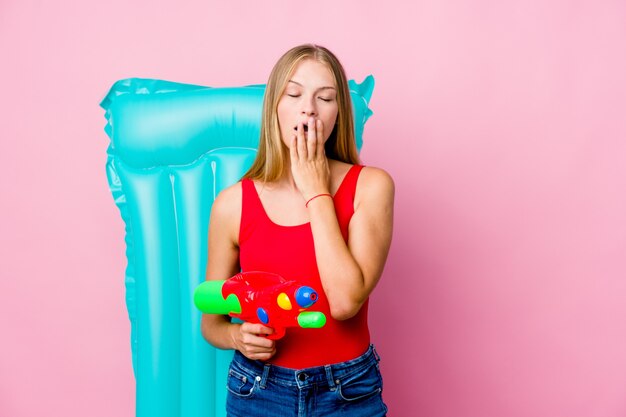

left=228, top=345, right=380, bottom=389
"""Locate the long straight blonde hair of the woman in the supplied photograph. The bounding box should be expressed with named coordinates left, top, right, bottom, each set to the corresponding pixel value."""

left=243, top=44, right=360, bottom=182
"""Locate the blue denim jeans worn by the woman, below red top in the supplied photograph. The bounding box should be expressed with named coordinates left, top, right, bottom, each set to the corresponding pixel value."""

left=226, top=346, right=387, bottom=417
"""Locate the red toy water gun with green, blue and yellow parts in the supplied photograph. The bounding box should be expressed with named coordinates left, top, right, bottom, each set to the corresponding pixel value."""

left=193, top=272, right=326, bottom=340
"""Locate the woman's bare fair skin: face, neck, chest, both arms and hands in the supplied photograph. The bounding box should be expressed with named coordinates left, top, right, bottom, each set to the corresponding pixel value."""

left=202, top=60, right=394, bottom=360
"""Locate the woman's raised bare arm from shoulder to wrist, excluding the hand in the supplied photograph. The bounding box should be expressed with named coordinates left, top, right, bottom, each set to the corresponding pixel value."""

left=308, top=167, right=394, bottom=320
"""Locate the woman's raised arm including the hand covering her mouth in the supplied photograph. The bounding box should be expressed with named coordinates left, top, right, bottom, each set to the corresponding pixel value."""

left=289, top=118, right=394, bottom=320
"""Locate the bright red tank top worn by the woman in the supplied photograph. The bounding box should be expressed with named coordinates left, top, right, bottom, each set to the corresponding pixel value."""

left=239, top=165, right=370, bottom=369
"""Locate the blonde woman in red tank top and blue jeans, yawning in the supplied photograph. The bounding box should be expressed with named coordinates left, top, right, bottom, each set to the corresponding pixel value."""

left=202, top=45, right=394, bottom=417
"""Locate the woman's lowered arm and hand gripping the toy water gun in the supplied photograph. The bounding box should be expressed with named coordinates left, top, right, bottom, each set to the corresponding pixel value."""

left=201, top=182, right=276, bottom=360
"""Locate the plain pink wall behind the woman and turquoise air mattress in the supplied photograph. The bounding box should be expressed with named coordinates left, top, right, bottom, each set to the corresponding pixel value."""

left=0, top=0, right=626, bottom=417
